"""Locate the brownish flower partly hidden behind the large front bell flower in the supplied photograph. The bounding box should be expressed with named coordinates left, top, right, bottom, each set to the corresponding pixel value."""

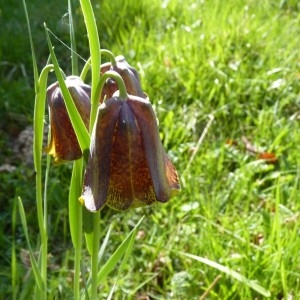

left=100, top=55, right=147, bottom=103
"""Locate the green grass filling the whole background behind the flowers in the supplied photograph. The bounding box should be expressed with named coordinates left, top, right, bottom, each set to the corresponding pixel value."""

left=0, top=0, right=300, bottom=299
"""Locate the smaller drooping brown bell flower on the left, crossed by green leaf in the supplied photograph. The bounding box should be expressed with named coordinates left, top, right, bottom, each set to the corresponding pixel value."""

left=44, top=76, right=91, bottom=164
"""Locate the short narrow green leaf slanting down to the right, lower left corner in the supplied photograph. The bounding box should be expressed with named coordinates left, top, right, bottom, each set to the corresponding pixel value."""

left=18, top=197, right=45, bottom=291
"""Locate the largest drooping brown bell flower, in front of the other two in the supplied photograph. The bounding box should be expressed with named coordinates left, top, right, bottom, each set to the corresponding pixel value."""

left=79, top=95, right=180, bottom=212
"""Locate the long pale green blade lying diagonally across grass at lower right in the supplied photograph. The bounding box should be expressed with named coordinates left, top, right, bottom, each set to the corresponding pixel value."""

left=179, top=252, right=271, bottom=297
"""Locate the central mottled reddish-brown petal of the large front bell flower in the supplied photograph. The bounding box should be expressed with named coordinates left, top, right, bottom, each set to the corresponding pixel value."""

left=107, top=102, right=156, bottom=210
